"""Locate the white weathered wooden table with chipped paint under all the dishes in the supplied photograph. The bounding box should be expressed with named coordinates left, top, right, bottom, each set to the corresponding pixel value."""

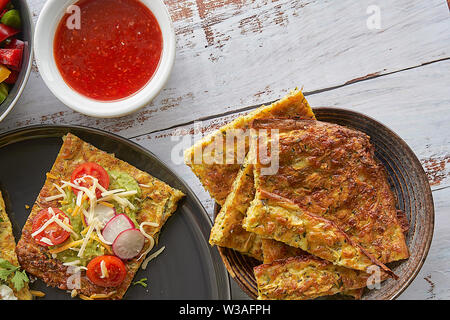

left=0, top=0, right=450, bottom=299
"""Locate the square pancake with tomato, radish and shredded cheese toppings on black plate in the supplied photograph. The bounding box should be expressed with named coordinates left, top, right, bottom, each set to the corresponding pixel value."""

left=16, top=133, right=184, bottom=299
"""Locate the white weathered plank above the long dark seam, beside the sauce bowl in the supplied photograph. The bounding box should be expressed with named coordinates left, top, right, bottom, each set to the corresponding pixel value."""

left=0, top=0, right=450, bottom=137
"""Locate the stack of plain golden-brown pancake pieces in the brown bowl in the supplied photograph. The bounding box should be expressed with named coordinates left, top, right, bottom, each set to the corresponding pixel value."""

left=185, top=90, right=409, bottom=300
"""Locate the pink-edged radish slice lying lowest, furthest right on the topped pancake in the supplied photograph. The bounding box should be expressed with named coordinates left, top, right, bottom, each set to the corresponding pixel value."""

left=112, top=229, right=145, bottom=260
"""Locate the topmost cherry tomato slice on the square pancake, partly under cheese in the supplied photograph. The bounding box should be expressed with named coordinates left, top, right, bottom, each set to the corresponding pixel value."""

left=71, top=162, right=109, bottom=198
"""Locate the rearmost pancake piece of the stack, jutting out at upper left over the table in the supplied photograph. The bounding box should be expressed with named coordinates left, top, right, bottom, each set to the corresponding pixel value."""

left=184, top=90, right=315, bottom=205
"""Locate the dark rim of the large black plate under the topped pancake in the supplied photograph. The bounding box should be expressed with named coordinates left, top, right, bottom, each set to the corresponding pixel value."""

left=0, top=124, right=231, bottom=300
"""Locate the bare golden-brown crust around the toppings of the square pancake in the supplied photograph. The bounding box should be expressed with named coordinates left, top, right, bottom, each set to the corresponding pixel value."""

left=16, top=133, right=184, bottom=299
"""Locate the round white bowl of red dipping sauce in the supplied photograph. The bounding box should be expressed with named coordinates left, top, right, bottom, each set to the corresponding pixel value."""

left=34, top=0, right=176, bottom=118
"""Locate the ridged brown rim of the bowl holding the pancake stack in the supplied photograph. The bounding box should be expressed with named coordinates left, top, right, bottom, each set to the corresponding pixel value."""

left=213, top=106, right=436, bottom=300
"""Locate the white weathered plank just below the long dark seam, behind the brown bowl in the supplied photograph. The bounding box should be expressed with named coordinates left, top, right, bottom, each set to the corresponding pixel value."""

left=129, top=60, right=450, bottom=220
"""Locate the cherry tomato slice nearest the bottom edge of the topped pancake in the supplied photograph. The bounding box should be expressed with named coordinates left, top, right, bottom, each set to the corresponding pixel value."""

left=86, top=256, right=127, bottom=287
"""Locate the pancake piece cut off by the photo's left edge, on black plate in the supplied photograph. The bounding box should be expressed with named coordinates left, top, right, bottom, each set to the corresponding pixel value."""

left=0, top=192, right=33, bottom=300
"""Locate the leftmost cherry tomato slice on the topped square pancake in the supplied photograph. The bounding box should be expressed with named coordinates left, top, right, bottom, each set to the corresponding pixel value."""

left=32, top=208, right=70, bottom=247
